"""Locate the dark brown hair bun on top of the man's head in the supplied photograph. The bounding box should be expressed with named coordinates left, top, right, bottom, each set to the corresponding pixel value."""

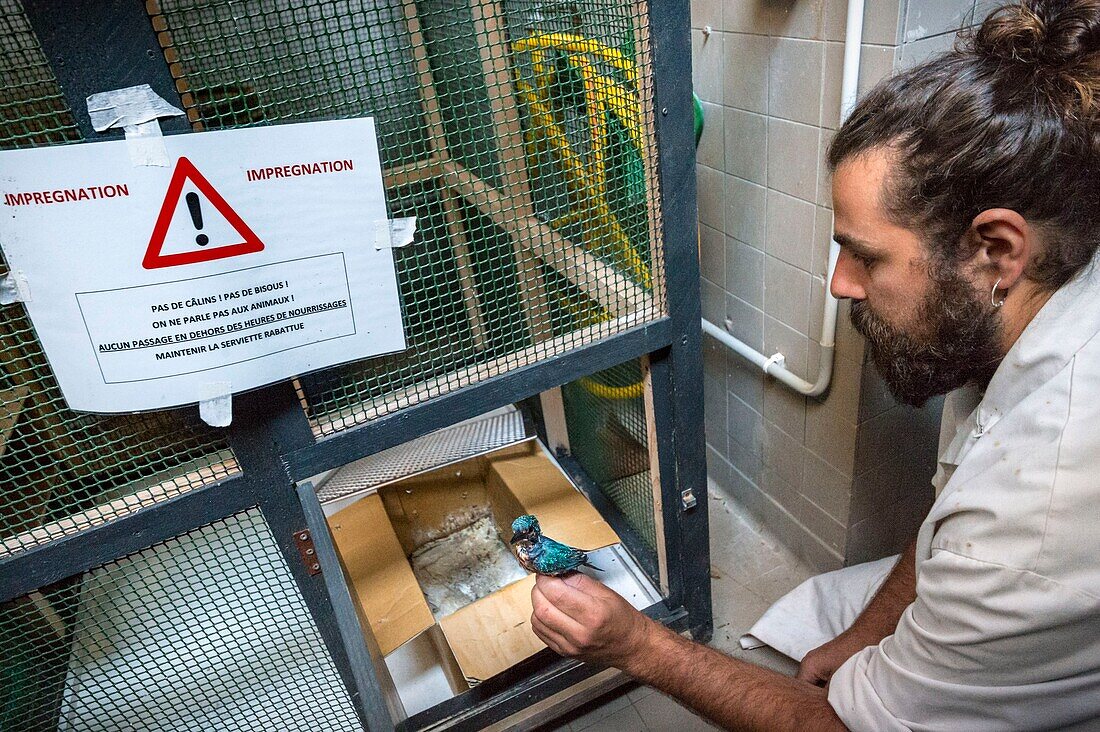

left=965, top=0, right=1100, bottom=69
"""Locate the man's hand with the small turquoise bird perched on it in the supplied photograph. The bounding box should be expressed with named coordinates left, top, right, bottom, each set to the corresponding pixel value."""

left=531, top=572, right=653, bottom=668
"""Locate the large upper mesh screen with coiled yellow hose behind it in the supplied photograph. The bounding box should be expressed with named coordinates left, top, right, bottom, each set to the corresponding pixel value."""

left=150, top=0, right=664, bottom=435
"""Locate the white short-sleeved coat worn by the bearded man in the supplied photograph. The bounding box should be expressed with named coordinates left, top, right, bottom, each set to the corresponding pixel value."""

left=828, top=259, right=1100, bottom=731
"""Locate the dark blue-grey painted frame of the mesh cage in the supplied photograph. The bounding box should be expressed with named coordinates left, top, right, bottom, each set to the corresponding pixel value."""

left=0, top=0, right=713, bottom=730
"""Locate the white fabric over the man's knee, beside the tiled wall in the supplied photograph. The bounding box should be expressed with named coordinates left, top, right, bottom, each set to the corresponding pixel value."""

left=740, top=555, right=898, bottom=660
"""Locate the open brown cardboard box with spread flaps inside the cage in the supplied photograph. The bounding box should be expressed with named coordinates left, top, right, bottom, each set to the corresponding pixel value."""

left=329, top=441, right=619, bottom=685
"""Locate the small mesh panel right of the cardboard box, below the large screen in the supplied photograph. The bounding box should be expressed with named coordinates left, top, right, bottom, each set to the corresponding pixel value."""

left=562, top=361, right=657, bottom=553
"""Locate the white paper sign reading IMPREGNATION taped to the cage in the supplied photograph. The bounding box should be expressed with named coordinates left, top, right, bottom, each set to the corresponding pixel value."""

left=0, top=119, right=405, bottom=412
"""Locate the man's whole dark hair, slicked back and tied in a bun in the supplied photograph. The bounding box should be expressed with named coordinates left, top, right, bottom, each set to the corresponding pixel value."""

left=828, top=0, right=1100, bottom=292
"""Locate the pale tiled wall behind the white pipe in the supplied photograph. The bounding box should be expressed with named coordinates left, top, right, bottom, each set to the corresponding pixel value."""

left=692, top=0, right=991, bottom=569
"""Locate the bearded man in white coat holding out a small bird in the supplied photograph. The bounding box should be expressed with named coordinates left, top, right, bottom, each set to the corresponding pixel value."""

left=523, top=0, right=1100, bottom=730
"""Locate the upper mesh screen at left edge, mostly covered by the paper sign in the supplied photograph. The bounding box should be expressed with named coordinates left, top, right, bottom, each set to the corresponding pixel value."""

left=0, top=0, right=237, bottom=557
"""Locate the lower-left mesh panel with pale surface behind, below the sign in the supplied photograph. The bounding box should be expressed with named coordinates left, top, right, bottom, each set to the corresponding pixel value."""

left=0, top=509, right=362, bottom=732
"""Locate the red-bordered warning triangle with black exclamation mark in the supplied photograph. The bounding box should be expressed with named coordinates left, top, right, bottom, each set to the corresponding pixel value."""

left=142, top=157, right=264, bottom=270
